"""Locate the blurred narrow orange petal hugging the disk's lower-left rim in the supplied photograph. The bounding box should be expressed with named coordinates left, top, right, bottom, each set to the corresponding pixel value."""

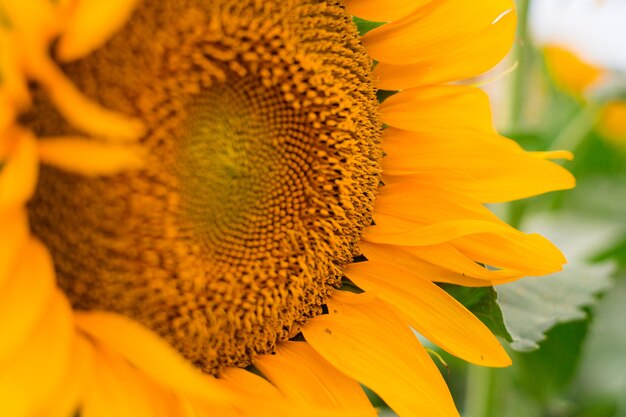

left=76, top=312, right=233, bottom=403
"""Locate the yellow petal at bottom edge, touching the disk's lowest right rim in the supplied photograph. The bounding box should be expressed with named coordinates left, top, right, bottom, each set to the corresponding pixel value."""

left=254, top=342, right=376, bottom=416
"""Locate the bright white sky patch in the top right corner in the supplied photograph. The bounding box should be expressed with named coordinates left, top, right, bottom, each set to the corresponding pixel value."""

left=529, top=0, right=626, bottom=71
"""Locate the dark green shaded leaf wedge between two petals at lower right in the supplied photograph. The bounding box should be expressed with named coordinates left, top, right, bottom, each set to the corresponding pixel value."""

left=439, top=284, right=513, bottom=342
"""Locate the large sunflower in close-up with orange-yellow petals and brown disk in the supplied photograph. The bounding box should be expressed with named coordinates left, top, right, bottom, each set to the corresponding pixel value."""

left=0, top=0, right=574, bottom=417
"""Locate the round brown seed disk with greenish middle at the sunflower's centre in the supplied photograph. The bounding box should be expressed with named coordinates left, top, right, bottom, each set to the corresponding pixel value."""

left=29, top=0, right=382, bottom=374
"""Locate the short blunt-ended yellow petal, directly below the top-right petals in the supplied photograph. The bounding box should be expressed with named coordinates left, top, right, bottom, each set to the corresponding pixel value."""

left=380, top=85, right=494, bottom=133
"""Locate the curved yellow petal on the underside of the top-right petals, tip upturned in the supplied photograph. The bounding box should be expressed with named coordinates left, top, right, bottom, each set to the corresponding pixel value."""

left=373, top=6, right=516, bottom=90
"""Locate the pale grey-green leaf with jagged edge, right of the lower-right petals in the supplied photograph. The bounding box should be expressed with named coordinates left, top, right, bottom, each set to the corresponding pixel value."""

left=497, top=263, right=613, bottom=352
